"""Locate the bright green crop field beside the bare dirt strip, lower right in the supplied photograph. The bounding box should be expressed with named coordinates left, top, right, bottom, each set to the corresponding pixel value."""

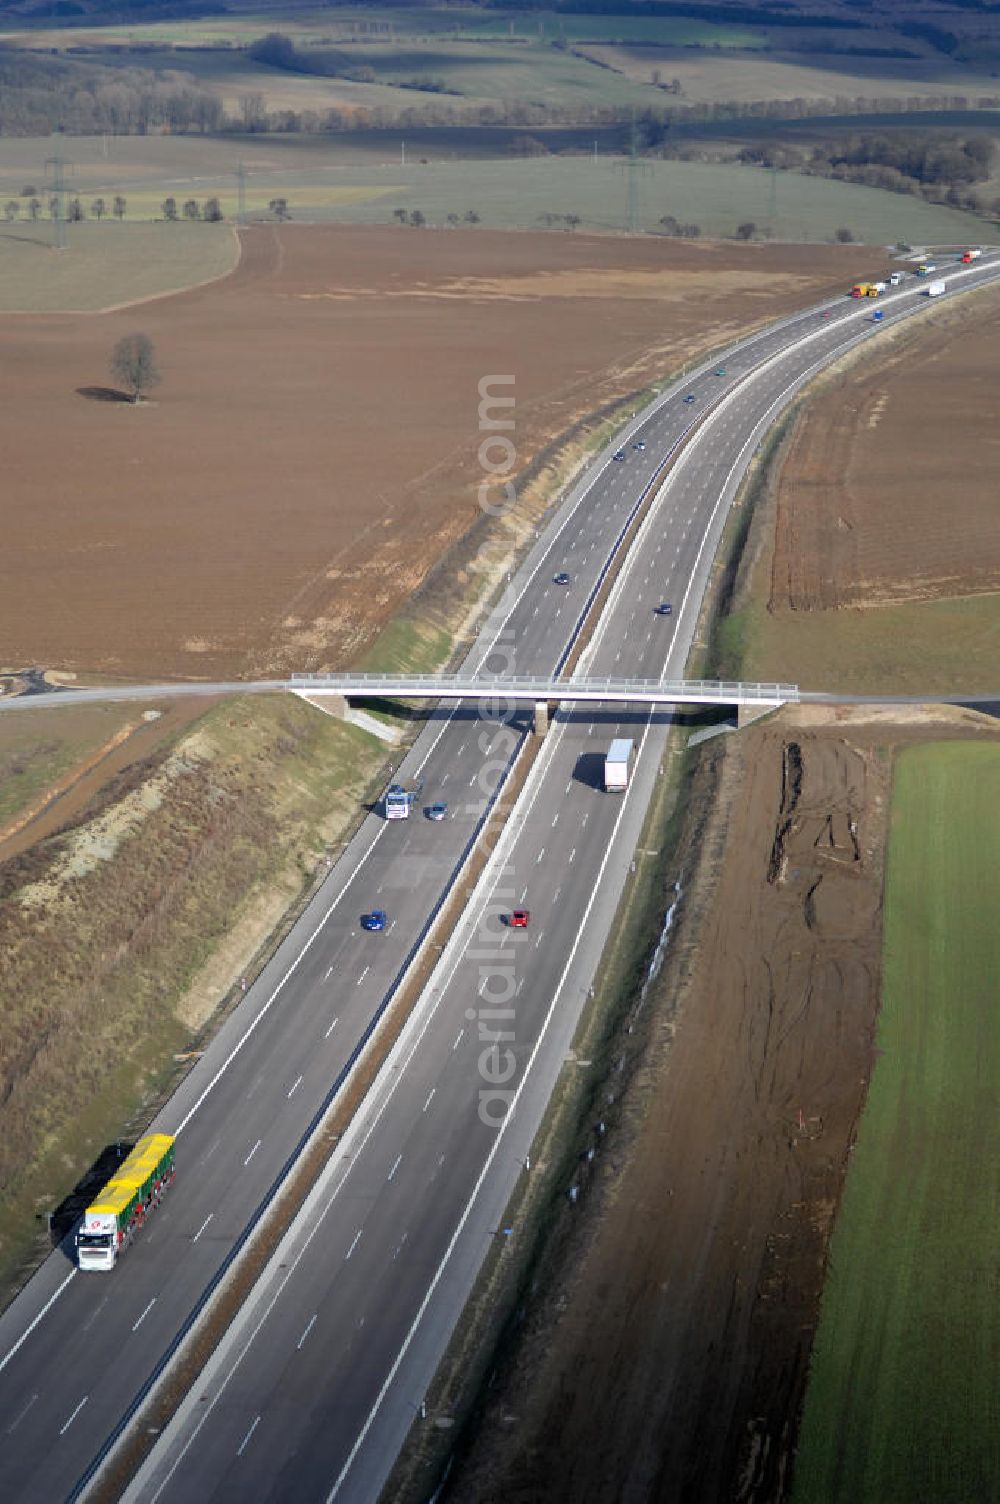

left=792, top=741, right=1000, bottom=1504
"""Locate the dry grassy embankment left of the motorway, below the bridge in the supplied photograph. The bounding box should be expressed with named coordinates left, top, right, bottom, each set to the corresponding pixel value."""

left=0, top=696, right=383, bottom=1298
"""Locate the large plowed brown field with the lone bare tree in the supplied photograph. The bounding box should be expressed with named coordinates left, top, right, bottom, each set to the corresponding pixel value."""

left=0, top=226, right=877, bottom=678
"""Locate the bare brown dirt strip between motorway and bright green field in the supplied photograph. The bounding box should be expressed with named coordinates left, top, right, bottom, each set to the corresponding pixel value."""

left=447, top=710, right=997, bottom=1504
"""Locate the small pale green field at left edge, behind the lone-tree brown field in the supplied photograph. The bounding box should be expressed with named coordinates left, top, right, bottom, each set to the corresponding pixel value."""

left=0, top=220, right=238, bottom=313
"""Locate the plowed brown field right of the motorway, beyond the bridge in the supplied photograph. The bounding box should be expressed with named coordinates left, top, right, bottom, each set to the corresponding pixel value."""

left=770, top=282, right=1000, bottom=612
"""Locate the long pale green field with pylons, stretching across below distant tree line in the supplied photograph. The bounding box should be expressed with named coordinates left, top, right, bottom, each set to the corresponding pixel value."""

left=0, top=132, right=982, bottom=252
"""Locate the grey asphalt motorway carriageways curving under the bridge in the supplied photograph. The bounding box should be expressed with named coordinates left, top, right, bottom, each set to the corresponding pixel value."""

left=0, top=257, right=1000, bottom=1504
